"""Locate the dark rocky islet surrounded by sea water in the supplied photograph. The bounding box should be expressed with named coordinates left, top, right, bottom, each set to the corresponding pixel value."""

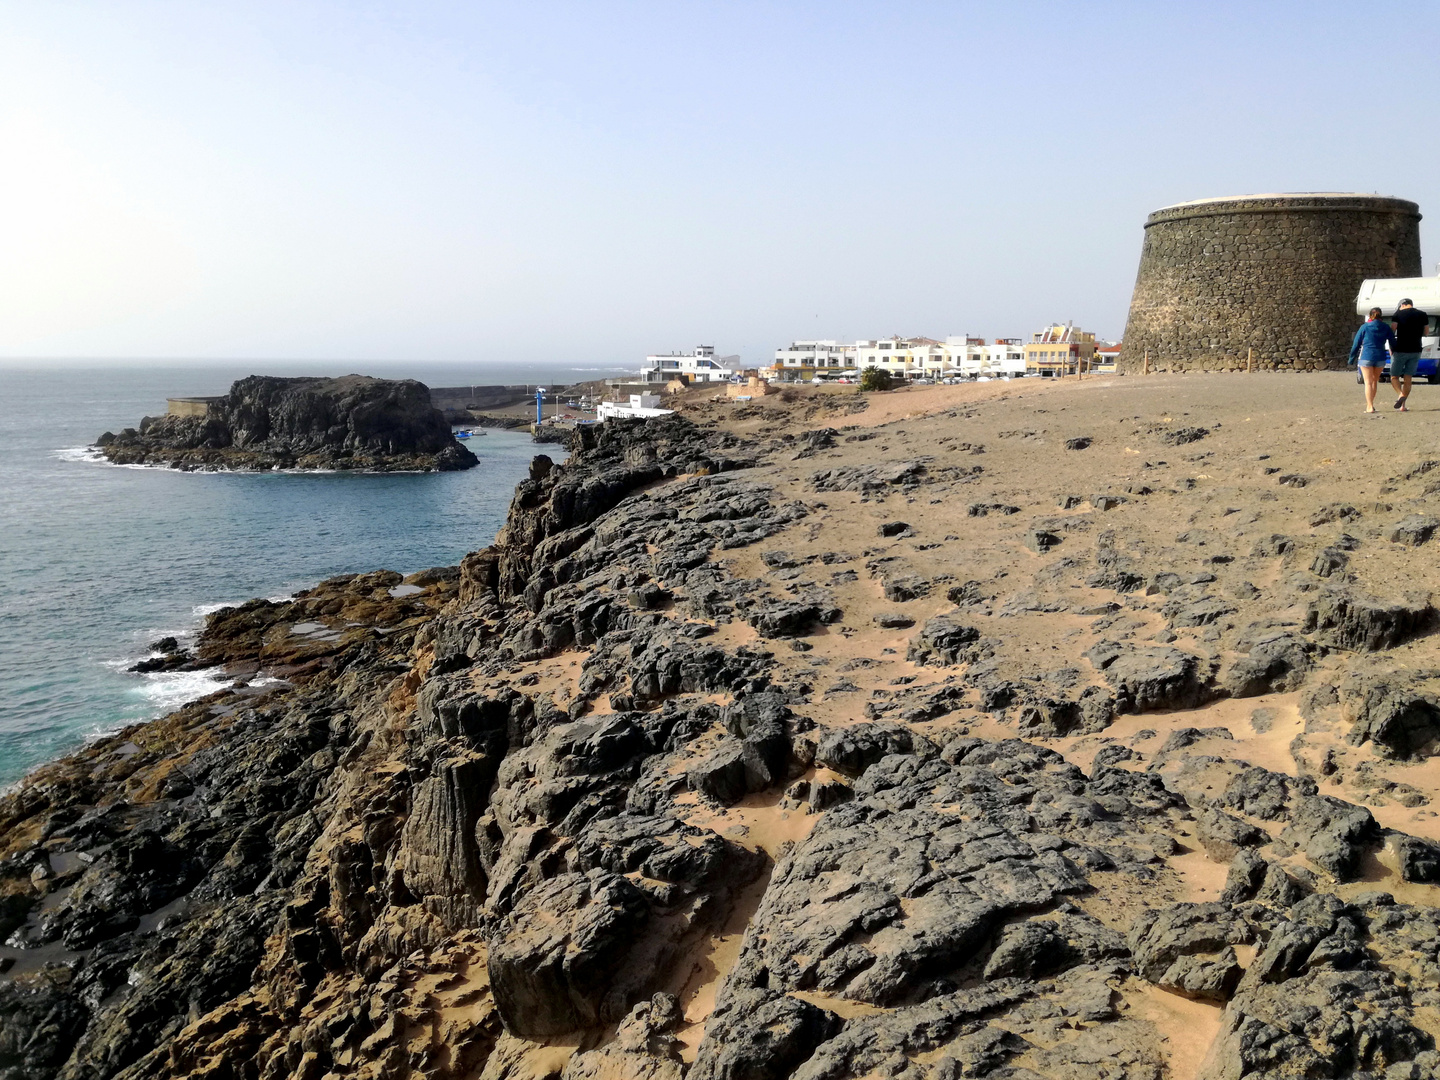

left=95, top=374, right=480, bottom=472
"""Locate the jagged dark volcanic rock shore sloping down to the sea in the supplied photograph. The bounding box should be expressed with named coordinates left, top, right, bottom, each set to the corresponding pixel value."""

left=8, top=388, right=1440, bottom=1080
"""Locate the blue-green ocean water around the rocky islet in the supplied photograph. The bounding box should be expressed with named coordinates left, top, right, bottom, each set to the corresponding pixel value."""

left=0, top=361, right=618, bottom=788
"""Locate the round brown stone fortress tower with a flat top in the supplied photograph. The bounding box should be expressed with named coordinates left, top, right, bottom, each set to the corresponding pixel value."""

left=1119, top=192, right=1420, bottom=373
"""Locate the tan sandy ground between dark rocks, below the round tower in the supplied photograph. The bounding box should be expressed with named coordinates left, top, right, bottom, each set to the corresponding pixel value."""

left=429, top=373, right=1440, bottom=1080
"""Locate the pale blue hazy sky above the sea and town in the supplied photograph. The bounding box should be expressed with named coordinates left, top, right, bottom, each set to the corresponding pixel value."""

left=0, top=0, right=1440, bottom=364
